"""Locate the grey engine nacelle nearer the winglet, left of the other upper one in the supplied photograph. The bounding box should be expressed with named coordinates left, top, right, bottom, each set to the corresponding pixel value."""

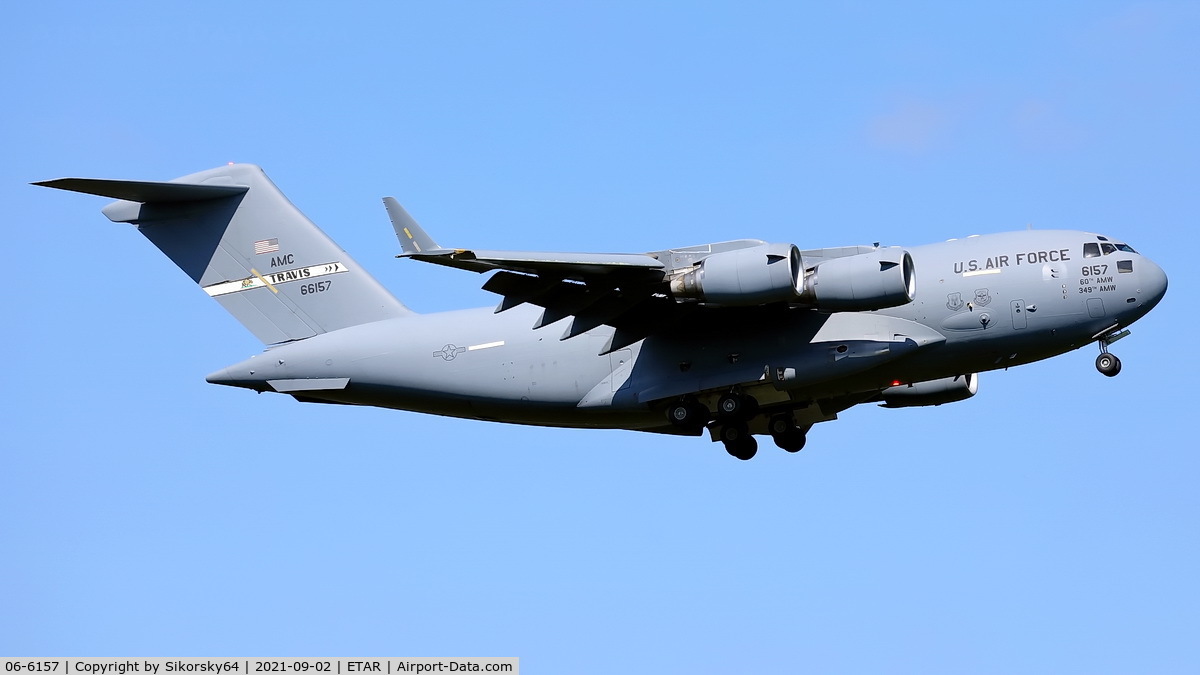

left=671, top=244, right=804, bottom=305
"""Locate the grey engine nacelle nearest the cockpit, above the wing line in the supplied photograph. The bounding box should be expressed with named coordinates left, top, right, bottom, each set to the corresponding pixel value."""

left=802, top=249, right=917, bottom=311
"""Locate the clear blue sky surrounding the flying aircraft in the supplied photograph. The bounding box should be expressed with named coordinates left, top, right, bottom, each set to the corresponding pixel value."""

left=0, top=1, right=1200, bottom=673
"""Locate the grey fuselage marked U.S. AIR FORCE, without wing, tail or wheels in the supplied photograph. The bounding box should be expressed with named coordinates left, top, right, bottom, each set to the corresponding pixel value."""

left=209, top=231, right=1166, bottom=430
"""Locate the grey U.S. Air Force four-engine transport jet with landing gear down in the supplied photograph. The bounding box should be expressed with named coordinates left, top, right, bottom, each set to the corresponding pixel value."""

left=35, top=165, right=1166, bottom=459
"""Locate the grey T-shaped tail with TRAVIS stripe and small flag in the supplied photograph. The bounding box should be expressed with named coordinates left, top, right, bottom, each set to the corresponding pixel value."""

left=35, top=165, right=412, bottom=345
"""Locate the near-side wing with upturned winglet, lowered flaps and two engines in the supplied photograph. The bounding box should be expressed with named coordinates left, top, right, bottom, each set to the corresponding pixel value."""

left=384, top=197, right=912, bottom=353
